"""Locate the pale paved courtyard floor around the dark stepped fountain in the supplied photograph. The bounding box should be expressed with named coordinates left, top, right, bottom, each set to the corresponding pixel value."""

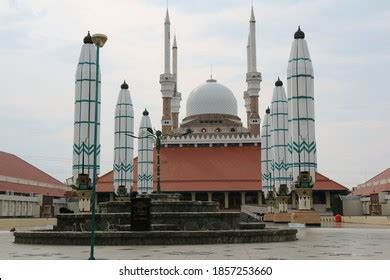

left=0, top=224, right=390, bottom=260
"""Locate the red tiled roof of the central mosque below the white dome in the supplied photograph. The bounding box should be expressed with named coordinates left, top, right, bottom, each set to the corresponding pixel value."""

left=97, top=146, right=348, bottom=192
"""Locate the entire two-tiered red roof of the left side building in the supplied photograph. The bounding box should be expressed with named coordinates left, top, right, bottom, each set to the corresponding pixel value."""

left=0, top=151, right=66, bottom=197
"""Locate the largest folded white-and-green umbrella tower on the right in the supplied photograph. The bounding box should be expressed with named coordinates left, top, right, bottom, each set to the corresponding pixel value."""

left=287, top=27, right=317, bottom=210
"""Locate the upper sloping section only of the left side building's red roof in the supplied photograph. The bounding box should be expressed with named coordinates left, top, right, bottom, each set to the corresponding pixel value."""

left=0, top=151, right=62, bottom=185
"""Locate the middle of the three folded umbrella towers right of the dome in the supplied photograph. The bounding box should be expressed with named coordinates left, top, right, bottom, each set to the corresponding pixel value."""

left=270, top=78, right=291, bottom=213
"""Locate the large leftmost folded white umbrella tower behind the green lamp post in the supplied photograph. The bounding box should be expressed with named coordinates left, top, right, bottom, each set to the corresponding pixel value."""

left=73, top=32, right=100, bottom=184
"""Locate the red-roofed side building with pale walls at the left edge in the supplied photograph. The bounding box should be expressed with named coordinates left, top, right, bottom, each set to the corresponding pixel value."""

left=0, top=151, right=71, bottom=218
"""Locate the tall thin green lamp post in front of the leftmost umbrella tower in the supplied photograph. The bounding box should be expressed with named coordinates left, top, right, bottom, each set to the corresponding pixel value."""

left=89, top=34, right=107, bottom=260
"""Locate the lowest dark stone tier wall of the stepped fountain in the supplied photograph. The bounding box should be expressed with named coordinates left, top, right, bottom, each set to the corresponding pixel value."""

left=14, top=229, right=297, bottom=246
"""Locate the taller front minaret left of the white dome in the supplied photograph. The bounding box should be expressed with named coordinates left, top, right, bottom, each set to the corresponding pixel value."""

left=160, top=9, right=175, bottom=134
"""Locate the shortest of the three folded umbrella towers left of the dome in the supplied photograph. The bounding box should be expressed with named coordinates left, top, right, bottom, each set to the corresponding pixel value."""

left=137, top=109, right=153, bottom=193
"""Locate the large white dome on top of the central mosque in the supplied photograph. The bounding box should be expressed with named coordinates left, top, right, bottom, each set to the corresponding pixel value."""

left=187, top=79, right=237, bottom=117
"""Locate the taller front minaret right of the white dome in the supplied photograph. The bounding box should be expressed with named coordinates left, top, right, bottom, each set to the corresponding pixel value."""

left=246, top=6, right=261, bottom=135
